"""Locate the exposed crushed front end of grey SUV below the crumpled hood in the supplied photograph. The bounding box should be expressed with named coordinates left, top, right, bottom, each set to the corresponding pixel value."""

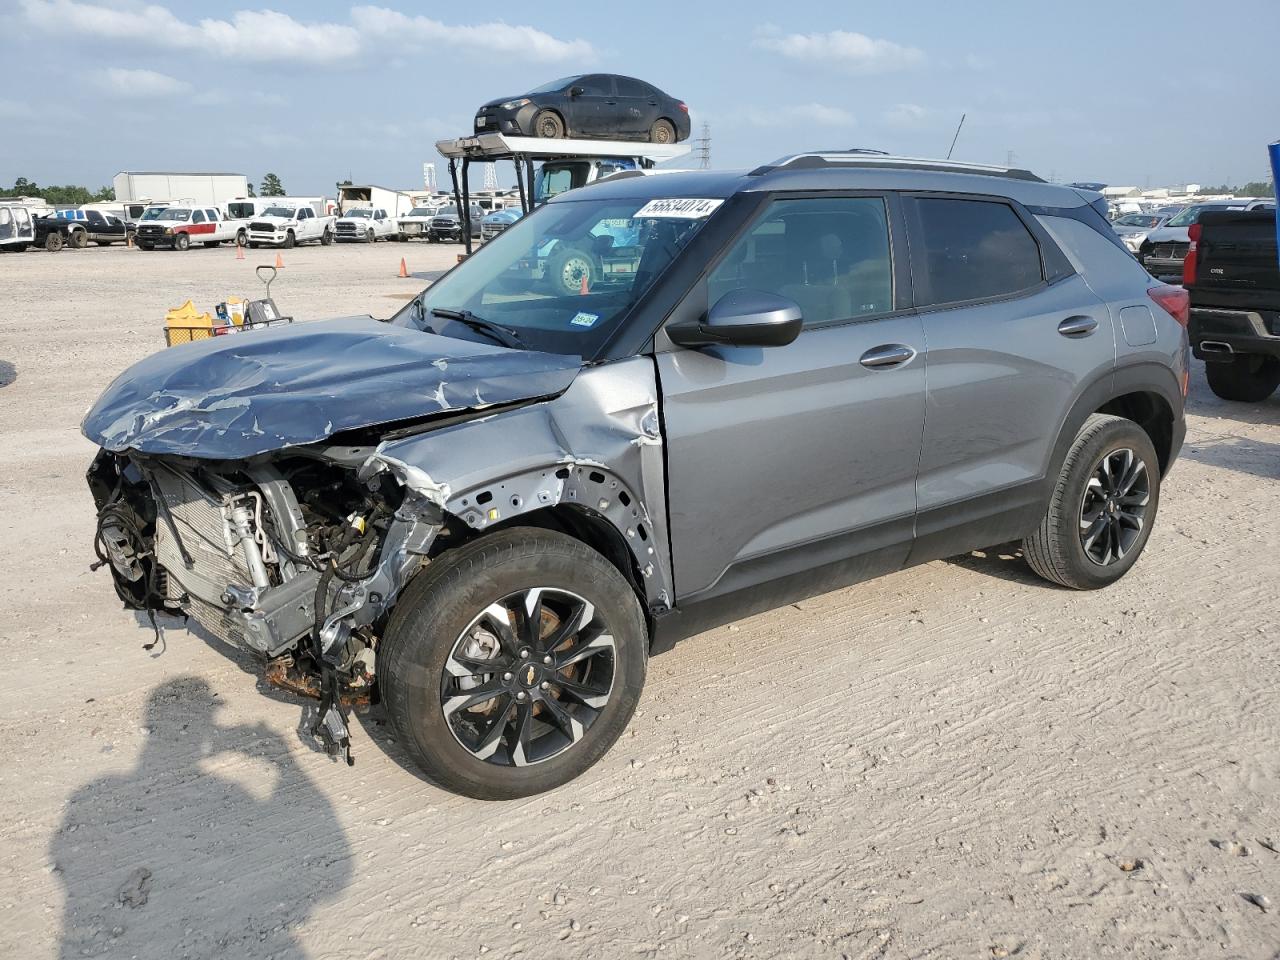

left=88, top=447, right=447, bottom=760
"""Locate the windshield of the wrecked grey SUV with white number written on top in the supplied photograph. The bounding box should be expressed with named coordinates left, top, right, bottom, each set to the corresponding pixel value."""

left=393, top=198, right=719, bottom=360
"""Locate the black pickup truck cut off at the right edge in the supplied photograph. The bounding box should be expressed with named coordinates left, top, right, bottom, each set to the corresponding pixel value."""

left=1183, top=210, right=1280, bottom=403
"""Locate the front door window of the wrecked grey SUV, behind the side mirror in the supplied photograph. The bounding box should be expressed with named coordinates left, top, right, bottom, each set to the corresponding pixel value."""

left=707, top=197, right=893, bottom=326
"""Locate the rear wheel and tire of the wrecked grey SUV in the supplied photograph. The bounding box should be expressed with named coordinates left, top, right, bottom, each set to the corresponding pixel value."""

left=1023, top=413, right=1160, bottom=590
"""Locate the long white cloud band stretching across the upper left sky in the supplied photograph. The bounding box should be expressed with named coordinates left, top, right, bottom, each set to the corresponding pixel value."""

left=20, top=0, right=595, bottom=64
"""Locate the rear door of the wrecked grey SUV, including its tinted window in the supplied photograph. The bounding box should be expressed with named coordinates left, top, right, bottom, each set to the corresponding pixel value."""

left=905, top=195, right=1116, bottom=562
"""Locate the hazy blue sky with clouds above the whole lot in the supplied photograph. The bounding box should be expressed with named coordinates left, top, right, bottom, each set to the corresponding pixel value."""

left=0, top=0, right=1280, bottom=193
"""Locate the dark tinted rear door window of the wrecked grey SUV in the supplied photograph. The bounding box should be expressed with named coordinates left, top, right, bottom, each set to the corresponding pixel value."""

left=910, top=197, right=1044, bottom=306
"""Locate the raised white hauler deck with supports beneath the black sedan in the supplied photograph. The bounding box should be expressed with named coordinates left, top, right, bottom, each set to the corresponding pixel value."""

left=435, top=133, right=691, bottom=253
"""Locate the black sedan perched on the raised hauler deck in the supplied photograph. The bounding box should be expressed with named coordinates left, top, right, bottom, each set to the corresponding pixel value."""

left=475, top=73, right=689, bottom=143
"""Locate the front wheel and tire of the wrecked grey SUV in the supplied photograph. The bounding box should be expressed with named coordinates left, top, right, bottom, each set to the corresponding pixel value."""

left=378, top=527, right=648, bottom=800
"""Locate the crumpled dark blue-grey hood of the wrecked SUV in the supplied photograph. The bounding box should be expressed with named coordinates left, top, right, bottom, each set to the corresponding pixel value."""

left=81, top=317, right=581, bottom=460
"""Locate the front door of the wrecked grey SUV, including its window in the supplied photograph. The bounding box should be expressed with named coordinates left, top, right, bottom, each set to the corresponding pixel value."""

left=657, top=193, right=924, bottom=602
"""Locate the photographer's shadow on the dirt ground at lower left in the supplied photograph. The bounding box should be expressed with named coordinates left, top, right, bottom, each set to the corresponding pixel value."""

left=50, top=677, right=352, bottom=960
